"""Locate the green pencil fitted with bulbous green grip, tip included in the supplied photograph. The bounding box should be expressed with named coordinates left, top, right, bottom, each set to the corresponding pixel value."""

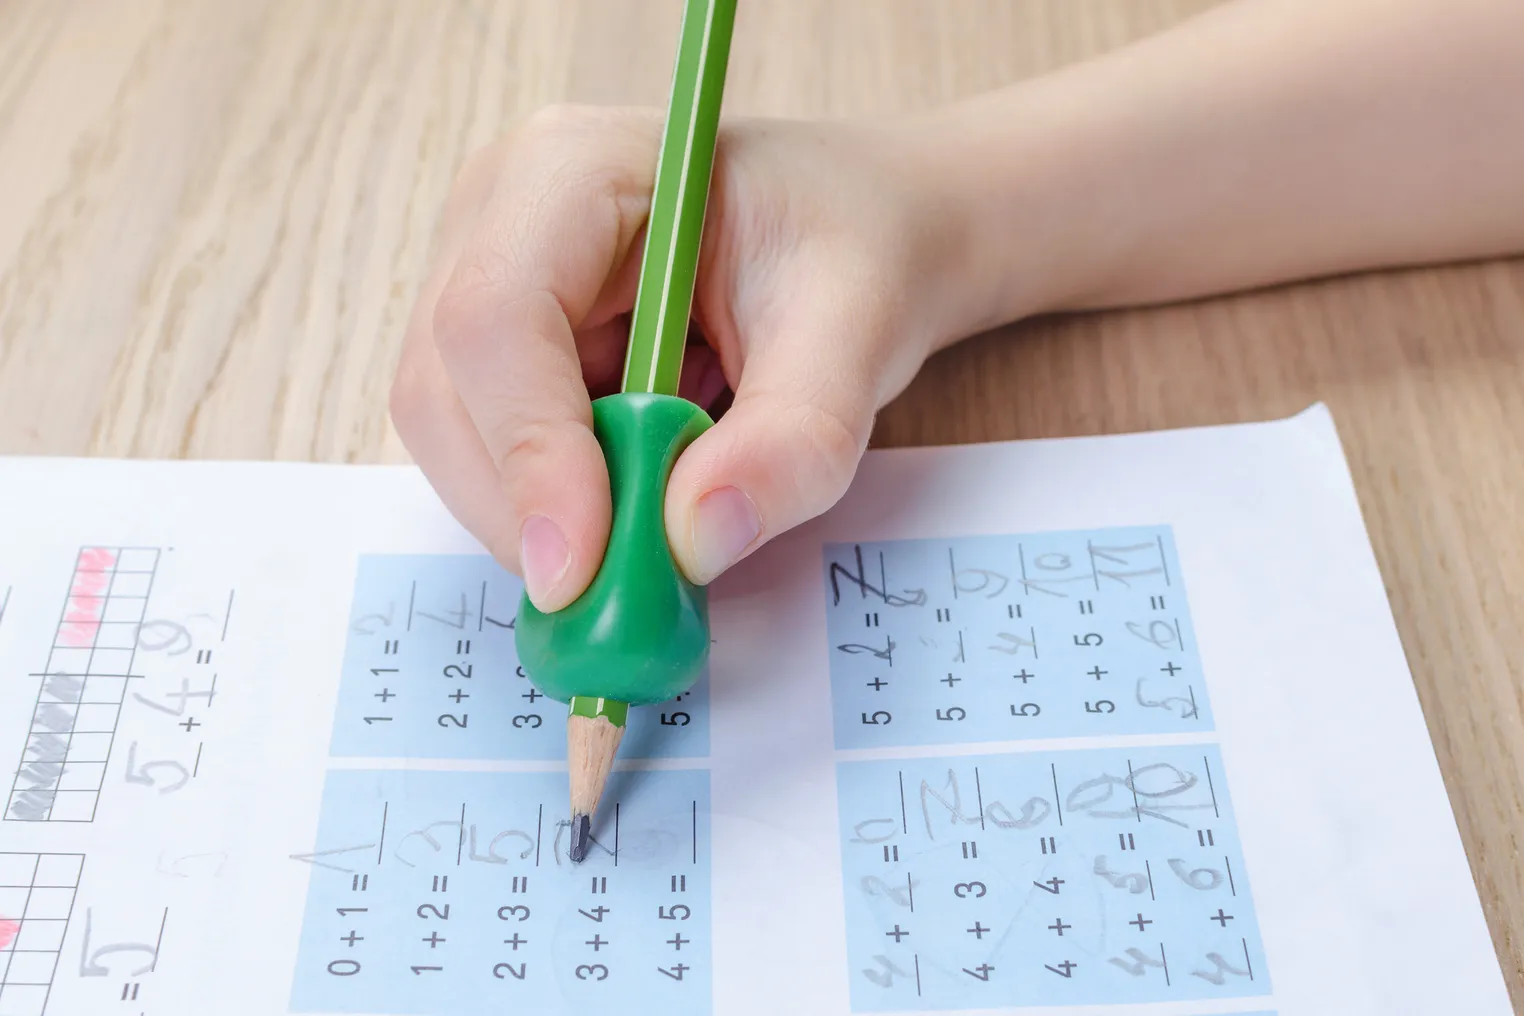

left=517, top=0, right=736, bottom=861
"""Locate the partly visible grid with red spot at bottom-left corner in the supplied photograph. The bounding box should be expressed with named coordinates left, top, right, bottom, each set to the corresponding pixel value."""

left=0, top=851, right=85, bottom=1016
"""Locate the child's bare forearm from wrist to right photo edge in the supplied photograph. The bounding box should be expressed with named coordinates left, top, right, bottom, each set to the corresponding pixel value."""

left=925, top=0, right=1524, bottom=334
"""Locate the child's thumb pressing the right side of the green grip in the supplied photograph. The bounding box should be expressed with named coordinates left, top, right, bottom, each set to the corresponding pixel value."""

left=666, top=329, right=878, bottom=585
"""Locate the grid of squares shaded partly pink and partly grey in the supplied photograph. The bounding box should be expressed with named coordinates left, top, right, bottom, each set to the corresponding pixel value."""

left=5, top=547, right=158, bottom=823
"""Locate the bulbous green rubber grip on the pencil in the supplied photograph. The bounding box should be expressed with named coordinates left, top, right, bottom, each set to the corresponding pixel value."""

left=515, top=393, right=713, bottom=705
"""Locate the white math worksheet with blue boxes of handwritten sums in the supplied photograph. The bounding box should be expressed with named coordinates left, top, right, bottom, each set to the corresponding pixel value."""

left=0, top=407, right=1510, bottom=1016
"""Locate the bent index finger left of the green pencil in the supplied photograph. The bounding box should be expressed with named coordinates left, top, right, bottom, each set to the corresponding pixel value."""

left=431, top=113, right=657, bottom=609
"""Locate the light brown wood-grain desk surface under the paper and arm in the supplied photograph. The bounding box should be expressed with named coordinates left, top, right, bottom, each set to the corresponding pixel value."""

left=0, top=0, right=1524, bottom=999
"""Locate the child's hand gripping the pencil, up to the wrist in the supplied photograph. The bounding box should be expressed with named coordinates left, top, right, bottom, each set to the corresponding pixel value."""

left=392, top=110, right=962, bottom=611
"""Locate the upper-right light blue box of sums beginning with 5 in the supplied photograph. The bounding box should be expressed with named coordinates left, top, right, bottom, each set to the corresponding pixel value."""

left=824, top=529, right=1212, bottom=748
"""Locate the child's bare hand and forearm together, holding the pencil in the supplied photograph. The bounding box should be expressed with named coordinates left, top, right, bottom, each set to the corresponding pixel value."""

left=392, top=0, right=1524, bottom=611
